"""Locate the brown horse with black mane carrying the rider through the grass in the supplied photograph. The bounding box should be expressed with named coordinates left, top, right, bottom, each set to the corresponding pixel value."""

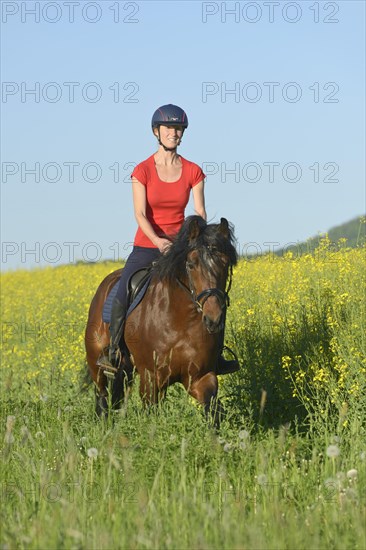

left=85, top=216, right=237, bottom=421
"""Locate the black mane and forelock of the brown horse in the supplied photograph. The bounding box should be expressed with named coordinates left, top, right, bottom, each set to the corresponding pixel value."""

left=153, top=216, right=237, bottom=281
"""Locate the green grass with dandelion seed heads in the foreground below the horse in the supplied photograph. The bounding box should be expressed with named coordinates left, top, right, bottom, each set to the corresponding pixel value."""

left=1, top=384, right=366, bottom=549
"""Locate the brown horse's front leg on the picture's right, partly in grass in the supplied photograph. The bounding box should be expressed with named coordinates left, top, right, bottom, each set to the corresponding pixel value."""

left=188, top=372, right=224, bottom=428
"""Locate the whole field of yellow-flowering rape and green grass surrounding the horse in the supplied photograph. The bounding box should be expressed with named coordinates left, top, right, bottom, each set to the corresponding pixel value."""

left=1, top=239, right=366, bottom=550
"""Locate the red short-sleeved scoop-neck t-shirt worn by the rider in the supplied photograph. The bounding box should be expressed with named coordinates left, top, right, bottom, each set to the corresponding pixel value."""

left=131, top=155, right=205, bottom=248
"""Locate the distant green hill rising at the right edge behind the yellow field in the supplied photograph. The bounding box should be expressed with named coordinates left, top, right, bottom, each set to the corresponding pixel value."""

left=274, top=216, right=366, bottom=256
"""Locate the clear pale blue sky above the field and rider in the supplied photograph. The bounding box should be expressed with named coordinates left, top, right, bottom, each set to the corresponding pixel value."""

left=1, top=0, right=365, bottom=270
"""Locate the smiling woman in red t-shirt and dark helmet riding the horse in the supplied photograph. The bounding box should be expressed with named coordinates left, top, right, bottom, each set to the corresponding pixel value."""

left=109, top=104, right=239, bottom=372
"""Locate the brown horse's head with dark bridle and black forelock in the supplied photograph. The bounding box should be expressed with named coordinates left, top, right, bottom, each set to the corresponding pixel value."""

left=185, top=216, right=237, bottom=334
